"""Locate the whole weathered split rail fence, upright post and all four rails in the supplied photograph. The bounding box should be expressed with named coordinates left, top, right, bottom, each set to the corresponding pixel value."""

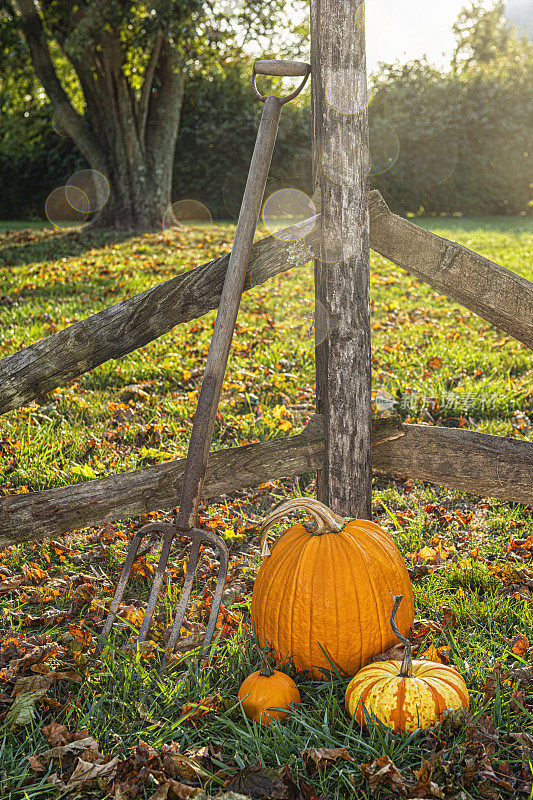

left=0, top=0, right=533, bottom=548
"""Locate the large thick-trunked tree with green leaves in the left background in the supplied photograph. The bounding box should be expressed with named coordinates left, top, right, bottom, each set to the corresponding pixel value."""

left=0, top=0, right=299, bottom=229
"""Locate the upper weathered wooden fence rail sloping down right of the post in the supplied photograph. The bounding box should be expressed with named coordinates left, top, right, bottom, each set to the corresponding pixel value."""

left=370, top=192, right=533, bottom=348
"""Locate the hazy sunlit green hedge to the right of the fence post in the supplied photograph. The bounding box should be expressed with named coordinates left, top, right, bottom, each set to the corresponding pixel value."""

left=370, top=54, right=533, bottom=214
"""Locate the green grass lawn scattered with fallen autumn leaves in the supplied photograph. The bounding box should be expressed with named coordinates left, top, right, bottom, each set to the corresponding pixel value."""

left=0, top=218, right=533, bottom=798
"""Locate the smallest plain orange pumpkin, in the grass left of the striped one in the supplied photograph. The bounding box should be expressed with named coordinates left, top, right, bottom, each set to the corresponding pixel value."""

left=239, top=647, right=300, bottom=726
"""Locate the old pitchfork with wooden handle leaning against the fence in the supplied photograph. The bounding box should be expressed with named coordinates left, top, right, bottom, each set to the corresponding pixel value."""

left=97, top=61, right=311, bottom=664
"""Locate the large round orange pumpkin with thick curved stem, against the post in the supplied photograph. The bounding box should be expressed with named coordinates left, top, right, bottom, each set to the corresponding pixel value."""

left=251, top=497, right=414, bottom=678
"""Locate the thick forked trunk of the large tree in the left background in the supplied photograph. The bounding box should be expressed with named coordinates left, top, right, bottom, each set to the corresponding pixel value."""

left=16, top=0, right=184, bottom=231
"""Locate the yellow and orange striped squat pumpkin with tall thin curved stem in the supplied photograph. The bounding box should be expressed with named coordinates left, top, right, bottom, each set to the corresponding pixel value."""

left=345, top=595, right=469, bottom=733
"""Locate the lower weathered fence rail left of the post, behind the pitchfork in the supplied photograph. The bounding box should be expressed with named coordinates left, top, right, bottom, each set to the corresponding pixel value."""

left=0, top=416, right=403, bottom=549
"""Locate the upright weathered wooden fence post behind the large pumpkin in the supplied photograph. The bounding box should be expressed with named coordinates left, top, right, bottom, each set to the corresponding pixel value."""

left=311, top=0, right=372, bottom=518
